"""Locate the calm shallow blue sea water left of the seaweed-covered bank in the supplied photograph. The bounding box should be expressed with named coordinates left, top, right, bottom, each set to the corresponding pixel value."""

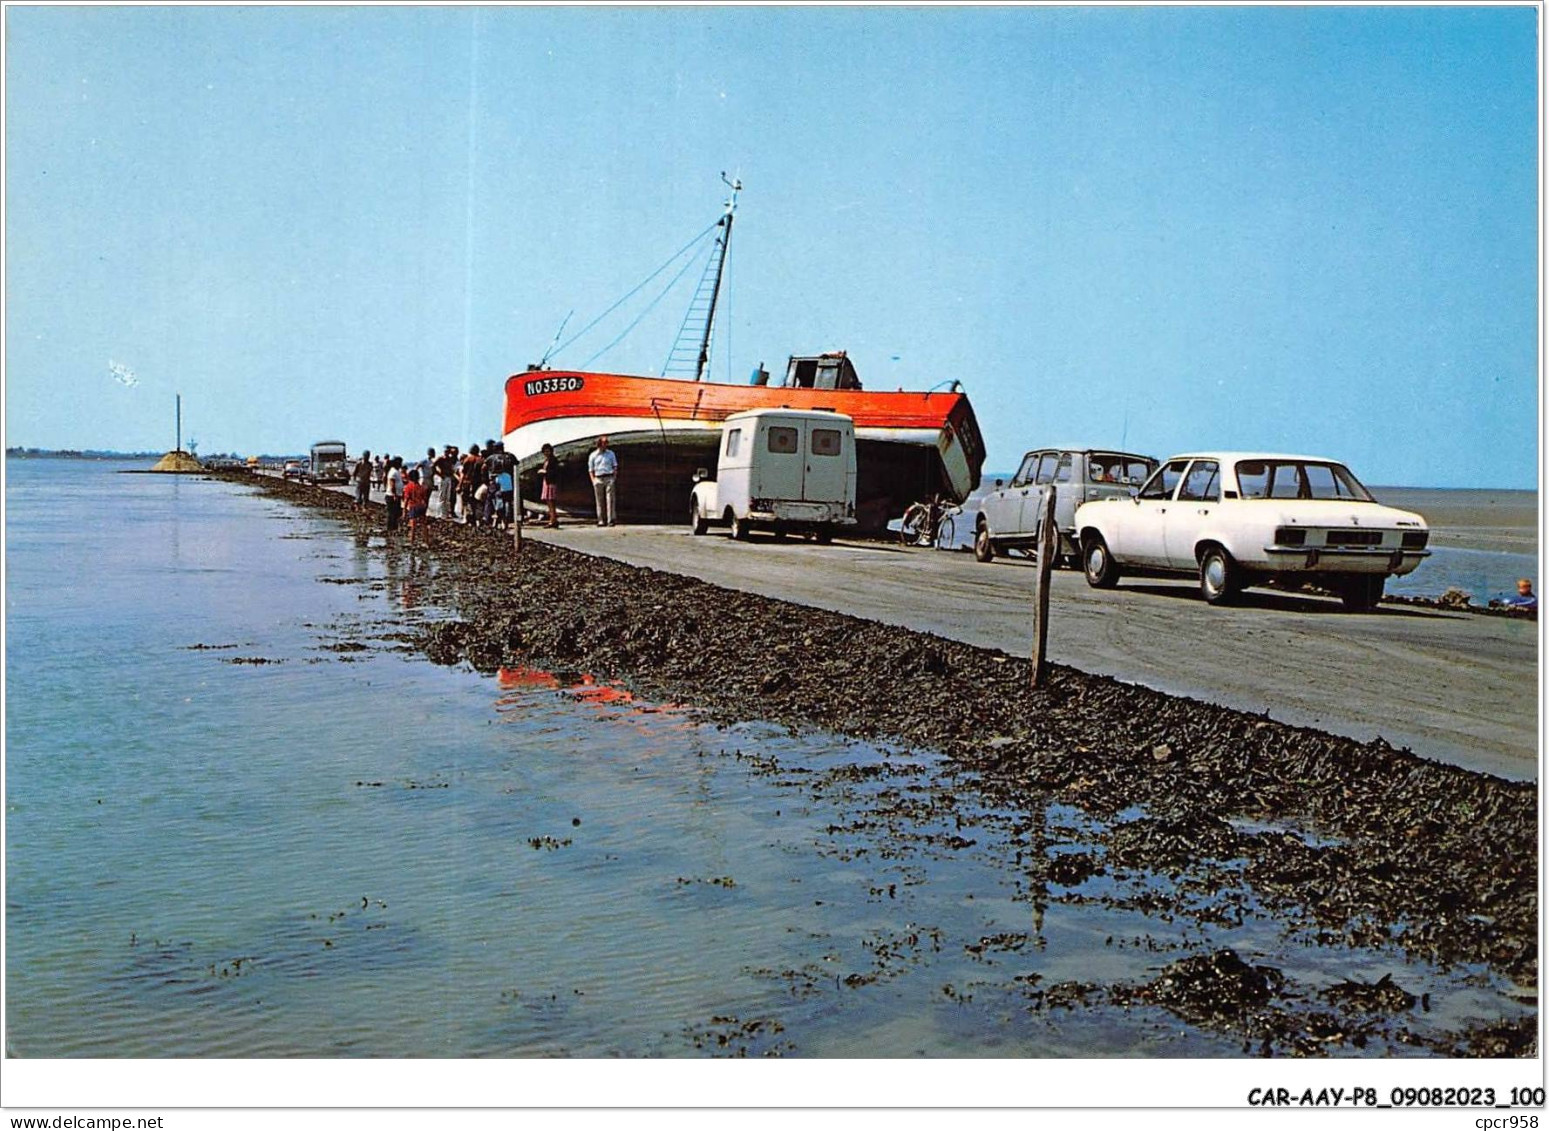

left=5, top=462, right=1523, bottom=1057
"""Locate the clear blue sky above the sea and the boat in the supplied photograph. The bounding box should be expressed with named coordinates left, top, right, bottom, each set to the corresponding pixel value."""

left=5, top=8, right=1538, bottom=486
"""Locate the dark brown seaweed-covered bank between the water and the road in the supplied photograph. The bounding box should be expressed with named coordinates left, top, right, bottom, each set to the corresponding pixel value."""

left=218, top=467, right=1538, bottom=1055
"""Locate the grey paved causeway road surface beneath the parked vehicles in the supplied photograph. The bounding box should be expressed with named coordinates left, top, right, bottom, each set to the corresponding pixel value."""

left=527, top=524, right=1538, bottom=779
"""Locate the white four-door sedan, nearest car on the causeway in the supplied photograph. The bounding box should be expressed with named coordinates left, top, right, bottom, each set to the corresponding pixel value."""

left=1075, top=452, right=1430, bottom=612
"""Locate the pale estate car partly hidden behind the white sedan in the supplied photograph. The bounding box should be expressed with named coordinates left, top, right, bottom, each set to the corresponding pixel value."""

left=973, top=448, right=1157, bottom=566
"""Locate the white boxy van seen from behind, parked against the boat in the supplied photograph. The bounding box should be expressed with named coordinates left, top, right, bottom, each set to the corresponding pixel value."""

left=689, top=409, right=855, bottom=542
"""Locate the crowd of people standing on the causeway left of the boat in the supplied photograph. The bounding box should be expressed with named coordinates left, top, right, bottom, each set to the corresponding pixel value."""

left=350, top=435, right=618, bottom=545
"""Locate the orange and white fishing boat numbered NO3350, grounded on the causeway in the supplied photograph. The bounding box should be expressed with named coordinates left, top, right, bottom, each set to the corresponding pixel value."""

left=503, top=181, right=985, bottom=531
